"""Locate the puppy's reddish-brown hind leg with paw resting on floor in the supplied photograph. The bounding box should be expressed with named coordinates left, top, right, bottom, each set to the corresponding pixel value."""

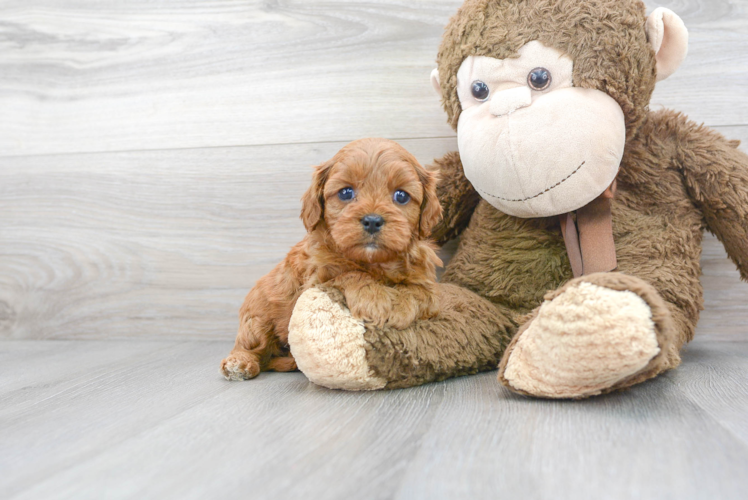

left=221, top=316, right=280, bottom=380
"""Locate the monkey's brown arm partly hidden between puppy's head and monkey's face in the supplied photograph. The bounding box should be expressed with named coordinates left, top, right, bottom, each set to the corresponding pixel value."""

left=431, top=151, right=481, bottom=245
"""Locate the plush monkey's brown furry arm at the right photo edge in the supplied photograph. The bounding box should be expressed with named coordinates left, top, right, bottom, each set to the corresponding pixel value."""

left=678, top=123, right=748, bottom=281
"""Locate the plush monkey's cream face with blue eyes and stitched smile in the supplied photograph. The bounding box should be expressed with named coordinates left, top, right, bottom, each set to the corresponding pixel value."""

left=450, top=41, right=626, bottom=217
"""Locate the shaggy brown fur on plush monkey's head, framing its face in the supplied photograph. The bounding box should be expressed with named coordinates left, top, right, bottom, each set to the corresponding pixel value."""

left=437, top=0, right=657, bottom=141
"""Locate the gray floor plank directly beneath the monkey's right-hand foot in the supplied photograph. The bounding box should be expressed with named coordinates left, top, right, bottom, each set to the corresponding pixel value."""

left=395, top=358, right=748, bottom=499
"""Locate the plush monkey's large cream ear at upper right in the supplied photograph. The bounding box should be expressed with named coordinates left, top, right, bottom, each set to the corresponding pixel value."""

left=646, top=7, right=688, bottom=82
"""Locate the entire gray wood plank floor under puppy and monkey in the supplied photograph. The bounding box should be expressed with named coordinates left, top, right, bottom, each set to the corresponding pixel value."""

left=0, top=338, right=748, bottom=500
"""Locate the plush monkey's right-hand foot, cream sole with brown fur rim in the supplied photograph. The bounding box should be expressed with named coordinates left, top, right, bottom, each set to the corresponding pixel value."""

left=499, top=273, right=679, bottom=399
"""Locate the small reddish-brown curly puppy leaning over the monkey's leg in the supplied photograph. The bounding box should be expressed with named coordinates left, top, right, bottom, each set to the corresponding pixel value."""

left=221, top=139, right=441, bottom=380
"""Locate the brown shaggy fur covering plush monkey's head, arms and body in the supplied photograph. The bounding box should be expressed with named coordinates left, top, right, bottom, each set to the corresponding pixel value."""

left=350, top=0, right=748, bottom=398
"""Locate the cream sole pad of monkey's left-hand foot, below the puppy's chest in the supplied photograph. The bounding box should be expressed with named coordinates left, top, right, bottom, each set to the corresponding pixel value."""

left=288, top=288, right=387, bottom=391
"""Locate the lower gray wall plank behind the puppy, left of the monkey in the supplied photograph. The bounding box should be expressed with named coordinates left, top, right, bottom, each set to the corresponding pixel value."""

left=0, top=138, right=456, bottom=339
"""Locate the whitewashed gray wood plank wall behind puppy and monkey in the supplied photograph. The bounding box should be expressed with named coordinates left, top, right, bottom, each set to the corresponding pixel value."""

left=0, top=0, right=748, bottom=340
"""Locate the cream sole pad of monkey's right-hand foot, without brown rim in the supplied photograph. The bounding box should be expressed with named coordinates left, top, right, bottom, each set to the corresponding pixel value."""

left=504, top=282, right=660, bottom=398
